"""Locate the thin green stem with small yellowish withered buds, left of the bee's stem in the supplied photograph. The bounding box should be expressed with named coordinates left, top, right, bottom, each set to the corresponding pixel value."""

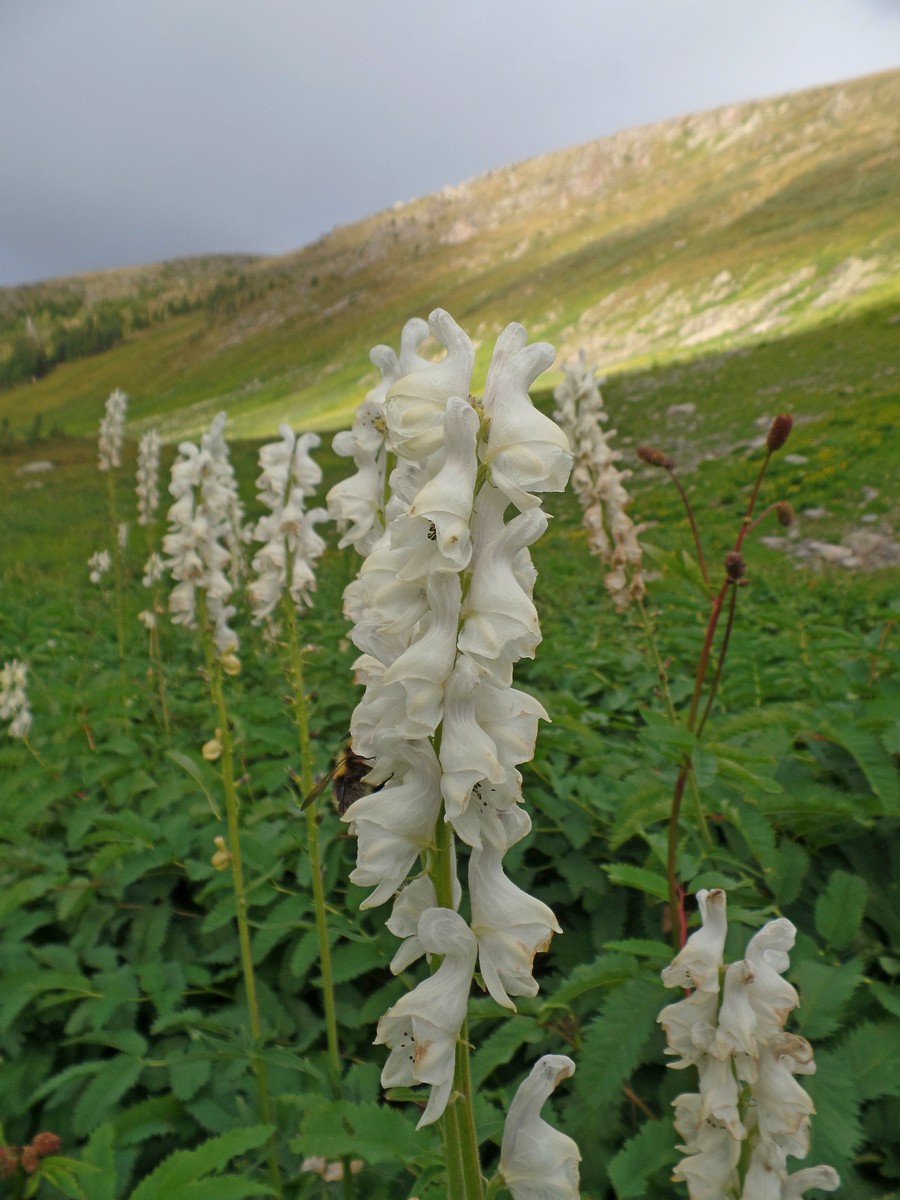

left=199, top=628, right=284, bottom=1198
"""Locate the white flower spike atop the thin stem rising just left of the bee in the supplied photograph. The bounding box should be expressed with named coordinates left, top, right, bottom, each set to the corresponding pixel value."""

left=247, top=425, right=328, bottom=622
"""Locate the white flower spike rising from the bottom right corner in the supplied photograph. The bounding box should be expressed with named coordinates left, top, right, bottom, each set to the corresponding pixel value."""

left=659, top=889, right=839, bottom=1200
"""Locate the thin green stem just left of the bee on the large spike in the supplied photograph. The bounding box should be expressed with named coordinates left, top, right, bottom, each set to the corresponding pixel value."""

left=282, top=597, right=356, bottom=1200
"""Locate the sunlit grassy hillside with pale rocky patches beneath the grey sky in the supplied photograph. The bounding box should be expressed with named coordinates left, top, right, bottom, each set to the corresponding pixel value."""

left=0, top=71, right=900, bottom=438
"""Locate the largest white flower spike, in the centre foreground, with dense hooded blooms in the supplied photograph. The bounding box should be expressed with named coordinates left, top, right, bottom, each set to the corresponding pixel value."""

left=340, top=310, right=571, bottom=1120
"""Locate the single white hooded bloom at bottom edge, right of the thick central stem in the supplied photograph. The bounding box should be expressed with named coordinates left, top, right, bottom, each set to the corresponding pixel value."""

left=500, top=1054, right=581, bottom=1200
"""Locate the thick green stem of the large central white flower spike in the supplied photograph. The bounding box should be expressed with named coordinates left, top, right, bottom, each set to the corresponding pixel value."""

left=428, top=801, right=485, bottom=1200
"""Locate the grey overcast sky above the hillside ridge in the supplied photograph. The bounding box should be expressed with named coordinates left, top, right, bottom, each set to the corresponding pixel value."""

left=0, top=0, right=900, bottom=284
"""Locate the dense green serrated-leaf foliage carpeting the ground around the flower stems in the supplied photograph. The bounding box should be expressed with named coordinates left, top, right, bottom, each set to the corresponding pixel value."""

left=0, top=312, right=900, bottom=1200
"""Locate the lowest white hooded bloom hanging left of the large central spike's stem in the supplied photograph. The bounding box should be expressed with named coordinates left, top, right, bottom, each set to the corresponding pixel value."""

left=376, top=908, right=478, bottom=1128
